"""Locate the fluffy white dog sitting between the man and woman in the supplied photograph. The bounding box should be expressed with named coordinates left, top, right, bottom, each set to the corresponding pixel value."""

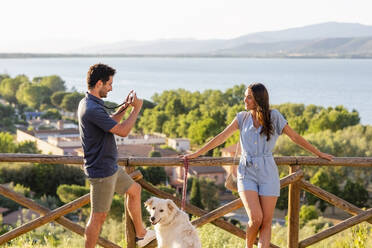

left=145, top=197, right=201, bottom=248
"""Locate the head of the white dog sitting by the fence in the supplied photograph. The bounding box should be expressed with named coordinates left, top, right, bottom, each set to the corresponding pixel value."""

left=145, top=197, right=179, bottom=225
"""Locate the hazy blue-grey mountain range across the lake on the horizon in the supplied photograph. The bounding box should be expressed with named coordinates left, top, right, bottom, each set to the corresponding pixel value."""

left=72, top=22, right=372, bottom=57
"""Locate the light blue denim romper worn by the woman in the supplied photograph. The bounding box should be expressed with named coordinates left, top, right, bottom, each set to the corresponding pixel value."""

left=236, top=109, right=287, bottom=196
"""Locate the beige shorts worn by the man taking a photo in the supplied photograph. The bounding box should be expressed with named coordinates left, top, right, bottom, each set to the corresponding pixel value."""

left=88, top=166, right=134, bottom=213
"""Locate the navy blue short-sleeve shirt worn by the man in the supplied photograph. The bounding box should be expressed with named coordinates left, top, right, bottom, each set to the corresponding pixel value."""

left=78, top=92, right=118, bottom=178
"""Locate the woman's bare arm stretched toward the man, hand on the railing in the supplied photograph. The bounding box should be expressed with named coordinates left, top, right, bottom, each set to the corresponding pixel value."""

left=184, top=118, right=239, bottom=159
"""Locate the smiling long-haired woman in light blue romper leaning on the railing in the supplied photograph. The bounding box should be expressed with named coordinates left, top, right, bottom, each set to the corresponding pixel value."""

left=184, top=83, right=333, bottom=248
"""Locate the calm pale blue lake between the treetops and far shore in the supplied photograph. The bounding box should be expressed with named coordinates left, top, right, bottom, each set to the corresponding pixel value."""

left=0, top=57, right=372, bottom=125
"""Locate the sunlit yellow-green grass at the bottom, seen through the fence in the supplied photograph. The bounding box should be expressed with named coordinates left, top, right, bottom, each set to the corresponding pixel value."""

left=3, top=212, right=372, bottom=248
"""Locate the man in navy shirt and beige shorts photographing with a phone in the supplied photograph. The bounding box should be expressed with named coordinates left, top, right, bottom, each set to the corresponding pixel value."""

left=78, top=64, right=155, bottom=248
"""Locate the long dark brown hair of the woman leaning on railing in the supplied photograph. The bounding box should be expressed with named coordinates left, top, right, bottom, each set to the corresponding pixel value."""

left=248, top=83, right=274, bottom=141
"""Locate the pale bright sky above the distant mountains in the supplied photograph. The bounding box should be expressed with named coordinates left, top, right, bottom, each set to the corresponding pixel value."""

left=0, top=0, right=372, bottom=53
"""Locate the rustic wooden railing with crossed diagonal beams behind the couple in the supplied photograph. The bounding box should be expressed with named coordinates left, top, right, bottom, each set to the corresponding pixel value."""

left=0, top=154, right=372, bottom=248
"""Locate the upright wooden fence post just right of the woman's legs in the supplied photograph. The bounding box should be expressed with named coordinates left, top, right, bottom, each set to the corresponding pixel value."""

left=287, top=165, right=301, bottom=248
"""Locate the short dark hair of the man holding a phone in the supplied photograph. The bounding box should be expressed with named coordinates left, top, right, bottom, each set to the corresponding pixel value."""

left=87, top=63, right=116, bottom=89
